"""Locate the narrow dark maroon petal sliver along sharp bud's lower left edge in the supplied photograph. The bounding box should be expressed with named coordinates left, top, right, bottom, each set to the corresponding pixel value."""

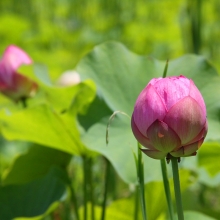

left=131, top=115, right=155, bottom=150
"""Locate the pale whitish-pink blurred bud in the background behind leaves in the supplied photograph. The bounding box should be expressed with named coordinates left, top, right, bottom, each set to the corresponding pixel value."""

left=58, top=70, right=81, bottom=86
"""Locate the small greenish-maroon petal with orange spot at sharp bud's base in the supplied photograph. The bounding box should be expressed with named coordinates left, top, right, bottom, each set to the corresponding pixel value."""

left=147, top=120, right=181, bottom=153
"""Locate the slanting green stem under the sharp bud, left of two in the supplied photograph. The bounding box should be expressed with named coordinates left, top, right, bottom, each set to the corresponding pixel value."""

left=160, top=159, right=174, bottom=220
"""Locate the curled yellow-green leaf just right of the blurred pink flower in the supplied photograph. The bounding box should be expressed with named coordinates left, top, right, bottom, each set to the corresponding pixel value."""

left=20, top=64, right=96, bottom=112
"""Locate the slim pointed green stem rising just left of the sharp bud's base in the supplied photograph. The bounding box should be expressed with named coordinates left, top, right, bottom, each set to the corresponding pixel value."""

left=137, top=143, right=147, bottom=220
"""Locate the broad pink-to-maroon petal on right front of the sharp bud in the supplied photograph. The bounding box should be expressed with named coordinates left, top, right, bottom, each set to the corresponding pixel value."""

left=163, top=97, right=206, bottom=145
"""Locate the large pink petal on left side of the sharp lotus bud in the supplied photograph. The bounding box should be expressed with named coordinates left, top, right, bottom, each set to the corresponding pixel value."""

left=133, top=84, right=167, bottom=136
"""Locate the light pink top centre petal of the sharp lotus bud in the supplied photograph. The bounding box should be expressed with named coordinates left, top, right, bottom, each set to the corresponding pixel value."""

left=154, top=76, right=190, bottom=111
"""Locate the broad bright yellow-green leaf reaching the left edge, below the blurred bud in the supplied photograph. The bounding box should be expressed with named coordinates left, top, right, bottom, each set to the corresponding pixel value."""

left=0, top=105, right=82, bottom=154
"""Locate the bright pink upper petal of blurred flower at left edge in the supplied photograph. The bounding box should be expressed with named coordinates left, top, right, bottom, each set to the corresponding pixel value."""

left=0, top=45, right=32, bottom=86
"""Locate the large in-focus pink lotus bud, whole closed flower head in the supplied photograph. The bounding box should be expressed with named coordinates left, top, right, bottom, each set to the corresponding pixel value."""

left=131, top=76, right=208, bottom=159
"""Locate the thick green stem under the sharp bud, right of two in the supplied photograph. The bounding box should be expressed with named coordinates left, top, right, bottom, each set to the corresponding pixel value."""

left=171, top=157, right=184, bottom=220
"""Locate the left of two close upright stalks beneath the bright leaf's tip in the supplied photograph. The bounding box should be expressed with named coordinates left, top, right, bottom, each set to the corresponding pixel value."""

left=83, top=156, right=88, bottom=220
